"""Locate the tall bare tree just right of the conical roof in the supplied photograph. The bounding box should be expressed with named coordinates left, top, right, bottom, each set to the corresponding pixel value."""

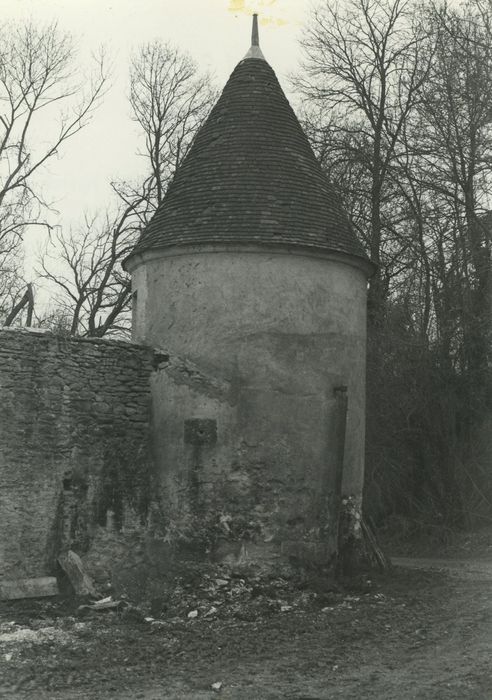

left=295, top=0, right=430, bottom=317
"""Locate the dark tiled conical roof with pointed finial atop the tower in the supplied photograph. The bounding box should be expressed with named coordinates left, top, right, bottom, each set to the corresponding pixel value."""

left=128, top=16, right=367, bottom=272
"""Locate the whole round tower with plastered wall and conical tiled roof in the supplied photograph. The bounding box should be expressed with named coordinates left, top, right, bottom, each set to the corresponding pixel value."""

left=126, top=16, right=371, bottom=562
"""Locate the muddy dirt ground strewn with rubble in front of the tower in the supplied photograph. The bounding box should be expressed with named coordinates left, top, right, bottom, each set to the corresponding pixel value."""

left=0, top=551, right=492, bottom=700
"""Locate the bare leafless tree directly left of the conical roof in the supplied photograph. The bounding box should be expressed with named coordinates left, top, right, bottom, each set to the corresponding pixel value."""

left=40, top=42, right=214, bottom=336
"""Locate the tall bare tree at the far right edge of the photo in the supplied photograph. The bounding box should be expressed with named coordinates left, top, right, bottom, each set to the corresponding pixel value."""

left=420, top=2, right=492, bottom=382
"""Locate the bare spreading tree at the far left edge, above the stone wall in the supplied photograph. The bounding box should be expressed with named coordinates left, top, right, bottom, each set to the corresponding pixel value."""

left=0, top=23, right=107, bottom=322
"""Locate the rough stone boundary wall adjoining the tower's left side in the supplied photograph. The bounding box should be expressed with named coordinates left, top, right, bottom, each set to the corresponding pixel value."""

left=0, top=329, right=153, bottom=578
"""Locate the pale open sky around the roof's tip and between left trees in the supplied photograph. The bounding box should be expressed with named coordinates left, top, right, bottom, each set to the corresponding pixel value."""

left=0, top=0, right=311, bottom=274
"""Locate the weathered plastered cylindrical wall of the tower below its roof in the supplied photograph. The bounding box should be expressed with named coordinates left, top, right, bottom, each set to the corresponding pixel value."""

left=133, top=250, right=366, bottom=568
